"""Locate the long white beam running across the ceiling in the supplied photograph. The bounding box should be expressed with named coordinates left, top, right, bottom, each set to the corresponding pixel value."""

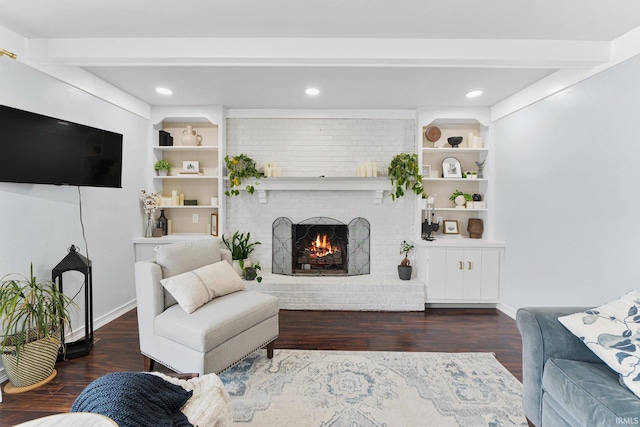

left=27, top=38, right=611, bottom=69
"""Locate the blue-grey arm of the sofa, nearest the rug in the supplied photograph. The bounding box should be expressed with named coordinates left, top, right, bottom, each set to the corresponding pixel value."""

left=516, top=307, right=602, bottom=425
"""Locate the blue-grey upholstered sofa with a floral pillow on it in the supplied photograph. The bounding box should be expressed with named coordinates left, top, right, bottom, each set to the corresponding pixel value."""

left=516, top=307, right=640, bottom=427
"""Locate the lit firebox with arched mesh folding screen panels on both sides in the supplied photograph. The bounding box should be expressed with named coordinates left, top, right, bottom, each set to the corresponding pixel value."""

left=272, top=217, right=370, bottom=276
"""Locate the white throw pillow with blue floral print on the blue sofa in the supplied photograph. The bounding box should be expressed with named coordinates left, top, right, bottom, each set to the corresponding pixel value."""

left=558, top=291, right=640, bottom=397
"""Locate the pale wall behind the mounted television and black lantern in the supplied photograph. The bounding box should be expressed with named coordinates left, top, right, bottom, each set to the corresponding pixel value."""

left=0, top=57, right=150, bottom=374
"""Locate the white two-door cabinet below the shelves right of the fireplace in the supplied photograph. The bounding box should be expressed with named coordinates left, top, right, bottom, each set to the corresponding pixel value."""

left=416, top=246, right=501, bottom=303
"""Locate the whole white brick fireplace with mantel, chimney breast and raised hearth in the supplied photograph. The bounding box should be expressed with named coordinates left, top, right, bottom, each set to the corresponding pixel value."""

left=225, top=117, right=425, bottom=311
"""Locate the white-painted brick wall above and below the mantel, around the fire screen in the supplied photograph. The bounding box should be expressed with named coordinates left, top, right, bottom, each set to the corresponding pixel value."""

left=227, top=118, right=418, bottom=275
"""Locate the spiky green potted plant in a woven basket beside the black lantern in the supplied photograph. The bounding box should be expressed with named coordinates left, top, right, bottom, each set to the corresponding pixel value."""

left=0, top=264, right=75, bottom=393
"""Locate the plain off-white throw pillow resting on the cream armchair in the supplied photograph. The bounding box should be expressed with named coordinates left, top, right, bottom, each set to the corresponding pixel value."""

left=160, top=261, right=245, bottom=314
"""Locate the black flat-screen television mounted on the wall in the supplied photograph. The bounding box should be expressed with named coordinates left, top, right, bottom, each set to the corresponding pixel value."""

left=0, top=105, right=122, bottom=188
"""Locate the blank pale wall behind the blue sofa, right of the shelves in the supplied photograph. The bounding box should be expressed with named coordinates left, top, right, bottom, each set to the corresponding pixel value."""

left=494, top=57, right=640, bottom=308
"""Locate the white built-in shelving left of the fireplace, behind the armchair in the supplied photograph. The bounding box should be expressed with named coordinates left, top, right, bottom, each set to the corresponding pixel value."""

left=134, top=107, right=226, bottom=259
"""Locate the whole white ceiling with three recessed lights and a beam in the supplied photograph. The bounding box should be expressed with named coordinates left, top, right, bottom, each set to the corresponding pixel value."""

left=0, top=0, right=640, bottom=109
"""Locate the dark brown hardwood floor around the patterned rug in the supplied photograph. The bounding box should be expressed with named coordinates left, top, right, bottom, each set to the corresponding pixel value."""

left=0, top=309, right=522, bottom=427
